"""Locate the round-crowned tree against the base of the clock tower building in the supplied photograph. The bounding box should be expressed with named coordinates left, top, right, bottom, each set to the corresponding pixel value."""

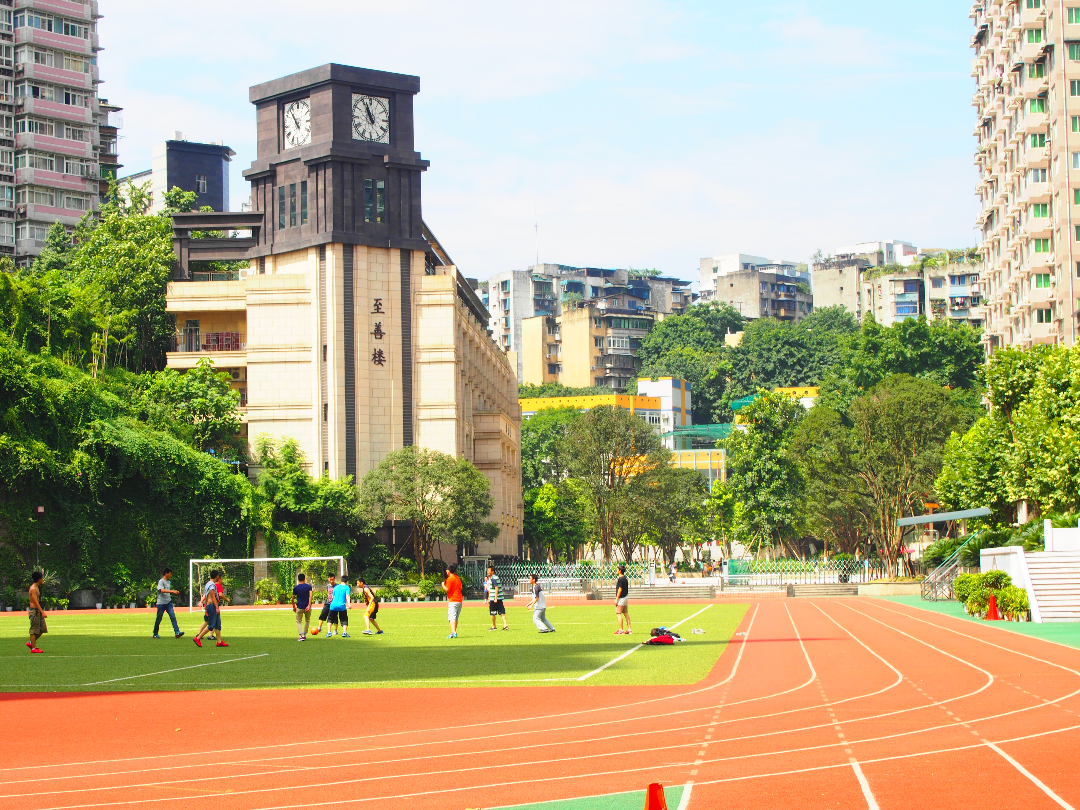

left=361, top=446, right=499, bottom=577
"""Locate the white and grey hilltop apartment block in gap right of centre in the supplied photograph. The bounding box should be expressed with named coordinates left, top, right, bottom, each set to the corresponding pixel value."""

left=698, top=253, right=813, bottom=322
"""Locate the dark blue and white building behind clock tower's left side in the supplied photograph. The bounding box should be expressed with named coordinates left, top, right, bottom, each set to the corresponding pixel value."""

left=121, top=132, right=235, bottom=213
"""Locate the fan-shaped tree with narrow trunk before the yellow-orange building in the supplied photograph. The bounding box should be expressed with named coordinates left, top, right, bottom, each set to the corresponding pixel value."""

left=559, top=405, right=671, bottom=559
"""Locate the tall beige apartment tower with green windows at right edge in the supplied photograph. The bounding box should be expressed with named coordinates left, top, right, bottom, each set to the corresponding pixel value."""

left=971, top=0, right=1080, bottom=353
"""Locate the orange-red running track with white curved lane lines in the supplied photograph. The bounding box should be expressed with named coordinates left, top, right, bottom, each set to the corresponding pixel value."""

left=0, top=598, right=1080, bottom=810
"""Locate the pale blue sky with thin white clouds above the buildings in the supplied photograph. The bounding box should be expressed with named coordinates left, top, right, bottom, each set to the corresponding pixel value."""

left=98, top=0, right=977, bottom=280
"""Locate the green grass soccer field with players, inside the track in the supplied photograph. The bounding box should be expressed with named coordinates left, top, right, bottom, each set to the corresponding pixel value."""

left=0, top=602, right=747, bottom=691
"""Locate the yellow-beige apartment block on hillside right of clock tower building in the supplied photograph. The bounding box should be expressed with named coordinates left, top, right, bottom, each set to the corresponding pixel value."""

left=521, top=300, right=657, bottom=391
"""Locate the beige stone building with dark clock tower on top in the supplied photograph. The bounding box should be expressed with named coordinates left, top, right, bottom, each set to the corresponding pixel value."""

left=167, top=65, right=523, bottom=557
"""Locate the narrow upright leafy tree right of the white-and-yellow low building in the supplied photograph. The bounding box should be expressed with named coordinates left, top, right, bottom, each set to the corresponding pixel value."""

left=723, top=389, right=806, bottom=550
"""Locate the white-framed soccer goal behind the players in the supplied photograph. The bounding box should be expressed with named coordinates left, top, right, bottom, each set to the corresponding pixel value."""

left=188, top=556, right=349, bottom=612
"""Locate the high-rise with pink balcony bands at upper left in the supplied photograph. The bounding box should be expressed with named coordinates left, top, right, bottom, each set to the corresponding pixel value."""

left=9, top=0, right=112, bottom=264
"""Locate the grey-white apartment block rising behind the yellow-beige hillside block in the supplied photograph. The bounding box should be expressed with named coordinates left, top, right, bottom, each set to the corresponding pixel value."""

left=485, top=264, right=692, bottom=384
